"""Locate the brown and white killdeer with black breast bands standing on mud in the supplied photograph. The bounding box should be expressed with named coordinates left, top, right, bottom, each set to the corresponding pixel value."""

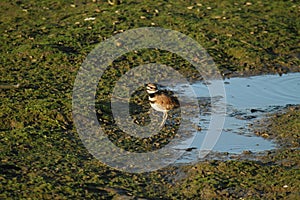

left=147, top=83, right=179, bottom=127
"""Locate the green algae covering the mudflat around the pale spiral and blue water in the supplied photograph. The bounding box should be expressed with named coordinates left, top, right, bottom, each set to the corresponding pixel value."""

left=0, top=0, right=300, bottom=199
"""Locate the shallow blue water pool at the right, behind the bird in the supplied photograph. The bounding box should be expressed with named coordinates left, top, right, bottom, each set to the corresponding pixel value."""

left=177, top=73, right=300, bottom=163
